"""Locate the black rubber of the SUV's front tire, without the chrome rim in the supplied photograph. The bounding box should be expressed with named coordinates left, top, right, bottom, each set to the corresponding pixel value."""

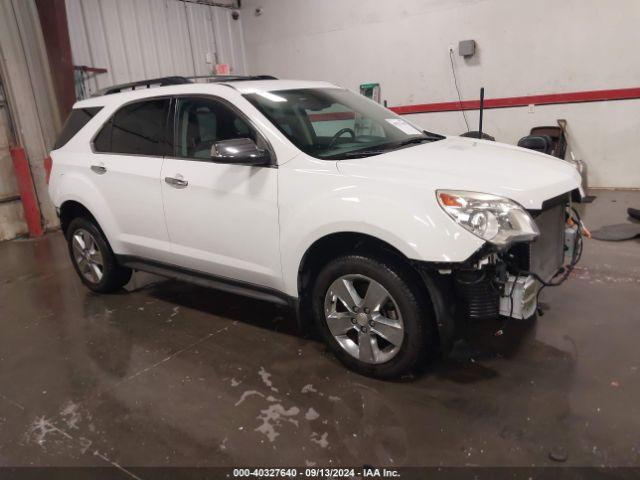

left=311, top=255, right=437, bottom=379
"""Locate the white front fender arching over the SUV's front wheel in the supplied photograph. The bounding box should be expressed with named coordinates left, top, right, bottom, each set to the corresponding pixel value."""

left=279, top=154, right=484, bottom=295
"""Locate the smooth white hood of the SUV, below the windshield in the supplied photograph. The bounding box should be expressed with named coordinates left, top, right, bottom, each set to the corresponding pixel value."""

left=337, top=137, right=581, bottom=209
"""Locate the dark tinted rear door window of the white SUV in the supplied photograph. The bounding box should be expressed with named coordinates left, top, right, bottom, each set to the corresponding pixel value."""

left=93, top=98, right=169, bottom=156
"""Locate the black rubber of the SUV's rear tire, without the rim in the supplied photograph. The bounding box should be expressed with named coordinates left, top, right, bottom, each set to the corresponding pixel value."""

left=66, top=217, right=132, bottom=293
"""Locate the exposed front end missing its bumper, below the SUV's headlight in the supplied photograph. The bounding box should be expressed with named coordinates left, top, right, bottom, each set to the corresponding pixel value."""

left=419, top=194, right=583, bottom=343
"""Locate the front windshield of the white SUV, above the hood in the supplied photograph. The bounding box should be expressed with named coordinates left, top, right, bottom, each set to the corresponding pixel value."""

left=244, top=88, right=444, bottom=159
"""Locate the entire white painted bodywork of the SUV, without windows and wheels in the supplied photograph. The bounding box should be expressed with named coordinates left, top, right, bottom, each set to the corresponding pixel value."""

left=49, top=80, right=581, bottom=297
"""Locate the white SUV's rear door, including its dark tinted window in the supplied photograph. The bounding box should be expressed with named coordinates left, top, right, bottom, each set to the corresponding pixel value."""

left=90, top=98, right=171, bottom=260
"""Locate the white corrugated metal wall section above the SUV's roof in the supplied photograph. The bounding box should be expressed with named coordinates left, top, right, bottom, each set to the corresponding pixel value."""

left=66, top=0, right=247, bottom=96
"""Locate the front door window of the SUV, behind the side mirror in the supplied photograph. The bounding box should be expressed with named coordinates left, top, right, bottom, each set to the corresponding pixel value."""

left=175, top=98, right=256, bottom=159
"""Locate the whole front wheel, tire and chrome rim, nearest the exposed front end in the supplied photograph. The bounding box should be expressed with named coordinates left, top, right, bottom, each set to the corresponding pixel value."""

left=311, top=255, right=437, bottom=379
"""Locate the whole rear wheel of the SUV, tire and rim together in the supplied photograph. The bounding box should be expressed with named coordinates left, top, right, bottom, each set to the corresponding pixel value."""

left=66, top=217, right=132, bottom=293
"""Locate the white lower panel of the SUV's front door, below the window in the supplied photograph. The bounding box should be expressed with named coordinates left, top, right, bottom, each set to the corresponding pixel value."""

left=162, top=158, right=282, bottom=289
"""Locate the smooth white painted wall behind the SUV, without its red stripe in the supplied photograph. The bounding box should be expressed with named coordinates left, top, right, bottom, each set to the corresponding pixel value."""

left=241, top=0, right=640, bottom=188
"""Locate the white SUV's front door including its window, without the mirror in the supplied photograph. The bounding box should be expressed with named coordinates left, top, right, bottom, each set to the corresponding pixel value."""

left=161, top=96, right=281, bottom=288
